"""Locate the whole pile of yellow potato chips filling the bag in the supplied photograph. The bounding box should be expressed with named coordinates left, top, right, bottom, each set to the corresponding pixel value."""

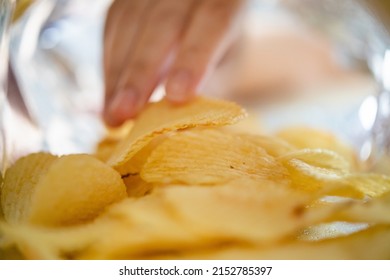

left=0, top=97, right=390, bottom=259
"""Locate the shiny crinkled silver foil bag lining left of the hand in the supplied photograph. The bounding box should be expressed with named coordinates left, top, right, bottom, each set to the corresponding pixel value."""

left=3, top=1, right=109, bottom=168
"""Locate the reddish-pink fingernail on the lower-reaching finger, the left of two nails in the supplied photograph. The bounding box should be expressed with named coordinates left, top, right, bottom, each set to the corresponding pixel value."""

left=105, top=89, right=139, bottom=126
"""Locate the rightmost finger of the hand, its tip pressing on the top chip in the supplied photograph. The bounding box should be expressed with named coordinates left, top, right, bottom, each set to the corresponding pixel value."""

left=166, top=0, right=242, bottom=103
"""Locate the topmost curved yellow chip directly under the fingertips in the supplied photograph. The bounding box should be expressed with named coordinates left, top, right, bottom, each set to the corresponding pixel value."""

left=108, top=96, right=246, bottom=167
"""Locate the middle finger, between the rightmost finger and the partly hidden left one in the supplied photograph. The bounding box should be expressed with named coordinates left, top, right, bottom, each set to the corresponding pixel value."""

left=105, top=0, right=193, bottom=124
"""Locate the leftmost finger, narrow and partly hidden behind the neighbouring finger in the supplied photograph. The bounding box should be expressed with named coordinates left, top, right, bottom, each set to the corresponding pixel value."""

left=103, top=0, right=148, bottom=116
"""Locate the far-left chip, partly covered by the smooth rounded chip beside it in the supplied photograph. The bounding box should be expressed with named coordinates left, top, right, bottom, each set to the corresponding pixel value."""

left=1, top=153, right=57, bottom=222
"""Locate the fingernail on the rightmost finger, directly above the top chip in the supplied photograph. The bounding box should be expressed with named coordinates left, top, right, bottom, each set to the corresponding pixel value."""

left=166, top=70, right=192, bottom=103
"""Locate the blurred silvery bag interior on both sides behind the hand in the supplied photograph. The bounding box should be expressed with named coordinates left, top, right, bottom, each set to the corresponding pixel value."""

left=2, top=0, right=390, bottom=172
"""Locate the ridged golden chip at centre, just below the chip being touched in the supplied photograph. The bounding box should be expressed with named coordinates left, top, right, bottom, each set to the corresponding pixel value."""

left=141, top=129, right=287, bottom=185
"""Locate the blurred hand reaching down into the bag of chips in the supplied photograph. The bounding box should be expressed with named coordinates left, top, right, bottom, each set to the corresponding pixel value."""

left=104, top=0, right=243, bottom=126
